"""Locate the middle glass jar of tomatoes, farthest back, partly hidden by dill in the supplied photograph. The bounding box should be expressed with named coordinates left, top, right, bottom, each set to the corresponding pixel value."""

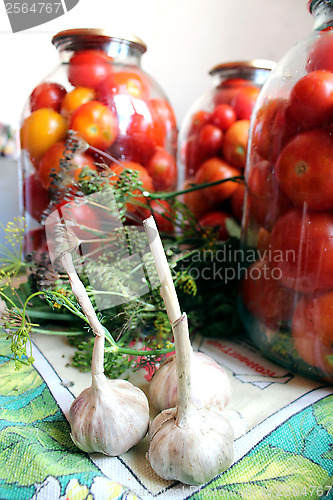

left=178, top=59, right=274, bottom=235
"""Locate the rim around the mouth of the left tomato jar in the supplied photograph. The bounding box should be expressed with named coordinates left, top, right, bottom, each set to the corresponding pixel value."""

left=52, top=28, right=147, bottom=54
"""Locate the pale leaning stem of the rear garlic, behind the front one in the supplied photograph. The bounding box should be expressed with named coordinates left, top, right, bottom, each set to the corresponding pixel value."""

left=143, top=215, right=181, bottom=325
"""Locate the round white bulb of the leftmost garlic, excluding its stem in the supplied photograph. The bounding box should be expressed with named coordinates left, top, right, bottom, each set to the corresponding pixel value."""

left=68, top=373, right=149, bottom=456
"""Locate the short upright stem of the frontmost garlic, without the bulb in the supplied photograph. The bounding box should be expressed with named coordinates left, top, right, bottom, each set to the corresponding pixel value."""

left=173, top=313, right=192, bottom=427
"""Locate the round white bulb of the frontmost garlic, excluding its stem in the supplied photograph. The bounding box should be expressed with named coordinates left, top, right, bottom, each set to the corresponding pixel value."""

left=148, top=408, right=234, bottom=485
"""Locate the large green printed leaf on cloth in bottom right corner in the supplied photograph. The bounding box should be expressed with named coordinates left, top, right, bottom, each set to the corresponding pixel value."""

left=193, top=445, right=332, bottom=500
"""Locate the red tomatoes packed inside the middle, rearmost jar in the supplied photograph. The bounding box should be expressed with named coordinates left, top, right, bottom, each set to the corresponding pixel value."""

left=181, top=78, right=260, bottom=240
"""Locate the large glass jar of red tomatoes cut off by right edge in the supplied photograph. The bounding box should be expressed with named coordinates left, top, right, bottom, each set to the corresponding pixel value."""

left=240, top=0, right=333, bottom=382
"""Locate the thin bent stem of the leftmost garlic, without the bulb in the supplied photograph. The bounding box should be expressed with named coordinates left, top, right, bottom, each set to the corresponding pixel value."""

left=60, top=252, right=105, bottom=375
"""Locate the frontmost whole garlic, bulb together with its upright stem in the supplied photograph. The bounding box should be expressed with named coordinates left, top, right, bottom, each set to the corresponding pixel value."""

left=148, top=315, right=234, bottom=485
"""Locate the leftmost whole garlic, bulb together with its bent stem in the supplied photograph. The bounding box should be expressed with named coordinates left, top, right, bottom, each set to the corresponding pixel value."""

left=61, top=252, right=149, bottom=456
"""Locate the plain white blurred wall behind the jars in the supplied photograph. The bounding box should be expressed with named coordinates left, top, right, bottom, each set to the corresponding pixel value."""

left=0, top=0, right=313, bottom=241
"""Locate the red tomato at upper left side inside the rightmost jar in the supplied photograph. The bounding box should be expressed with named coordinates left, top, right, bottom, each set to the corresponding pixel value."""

left=252, top=98, right=288, bottom=161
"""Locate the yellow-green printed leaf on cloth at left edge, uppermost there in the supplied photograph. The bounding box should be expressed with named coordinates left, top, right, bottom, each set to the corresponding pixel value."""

left=0, top=361, right=43, bottom=396
